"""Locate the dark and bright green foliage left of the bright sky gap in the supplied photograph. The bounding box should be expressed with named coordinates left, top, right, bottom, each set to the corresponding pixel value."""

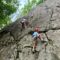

left=0, top=0, right=17, bottom=26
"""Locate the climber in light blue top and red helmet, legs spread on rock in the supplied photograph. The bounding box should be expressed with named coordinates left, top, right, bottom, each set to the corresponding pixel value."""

left=32, top=27, right=46, bottom=53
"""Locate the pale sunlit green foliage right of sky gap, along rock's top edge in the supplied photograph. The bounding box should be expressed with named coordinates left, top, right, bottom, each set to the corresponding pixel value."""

left=22, top=0, right=43, bottom=16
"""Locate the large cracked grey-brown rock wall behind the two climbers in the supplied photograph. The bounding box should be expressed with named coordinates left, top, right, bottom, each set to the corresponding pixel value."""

left=0, top=0, right=60, bottom=60
